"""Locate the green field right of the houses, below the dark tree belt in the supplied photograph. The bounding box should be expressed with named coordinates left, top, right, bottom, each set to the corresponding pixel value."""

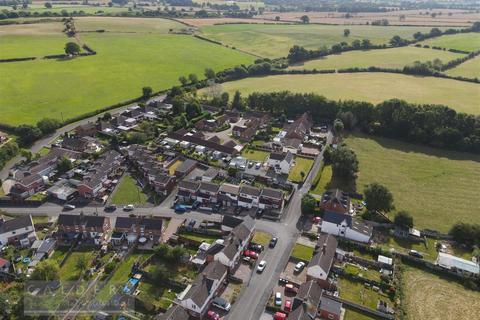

left=346, top=135, right=480, bottom=232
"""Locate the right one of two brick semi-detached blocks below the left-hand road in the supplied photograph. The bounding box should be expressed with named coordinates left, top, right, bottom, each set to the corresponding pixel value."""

left=111, top=217, right=163, bottom=245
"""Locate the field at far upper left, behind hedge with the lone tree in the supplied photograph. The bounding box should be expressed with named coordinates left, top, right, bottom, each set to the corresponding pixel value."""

left=0, top=22, right=70, bottom=59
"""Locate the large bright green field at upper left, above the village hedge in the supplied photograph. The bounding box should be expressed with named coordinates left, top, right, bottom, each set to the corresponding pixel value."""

left=0, top=26, right=253, bottom=125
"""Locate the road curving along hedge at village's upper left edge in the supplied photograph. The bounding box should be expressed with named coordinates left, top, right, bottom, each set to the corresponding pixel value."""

left=0, top=95, right=166, bottom=181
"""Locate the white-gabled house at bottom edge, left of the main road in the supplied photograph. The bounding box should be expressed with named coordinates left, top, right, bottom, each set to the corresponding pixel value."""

left=177, top=261, right=227, bottom=318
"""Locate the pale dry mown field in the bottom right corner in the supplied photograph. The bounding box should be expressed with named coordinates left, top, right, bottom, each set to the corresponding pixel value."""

left=402, top=267, right=480, bottom=320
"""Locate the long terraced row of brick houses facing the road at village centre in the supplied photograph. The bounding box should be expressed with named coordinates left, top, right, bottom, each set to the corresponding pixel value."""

left=177, top=180, right=284, bottom=211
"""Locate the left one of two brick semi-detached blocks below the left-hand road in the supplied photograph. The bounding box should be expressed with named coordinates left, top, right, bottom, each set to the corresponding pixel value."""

left=57, top=214, right=110, bottom=245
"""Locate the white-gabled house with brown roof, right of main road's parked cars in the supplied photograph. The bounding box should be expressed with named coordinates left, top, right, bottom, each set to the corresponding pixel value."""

left=307, top=234, right=338, bottom=289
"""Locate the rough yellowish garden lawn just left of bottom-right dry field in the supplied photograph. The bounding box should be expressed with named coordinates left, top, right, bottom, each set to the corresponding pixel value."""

left=337, top=278, right=393, bottom=310
